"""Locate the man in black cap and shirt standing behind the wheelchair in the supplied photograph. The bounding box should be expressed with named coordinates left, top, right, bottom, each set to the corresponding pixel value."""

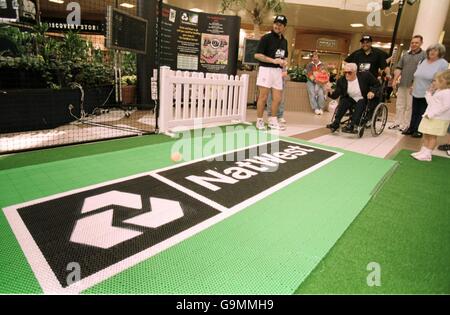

left=345, top=35, right=390, bottom=79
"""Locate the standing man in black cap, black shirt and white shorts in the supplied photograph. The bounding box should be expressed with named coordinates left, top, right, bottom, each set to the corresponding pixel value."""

left=255, top=15, right=288, bottom=130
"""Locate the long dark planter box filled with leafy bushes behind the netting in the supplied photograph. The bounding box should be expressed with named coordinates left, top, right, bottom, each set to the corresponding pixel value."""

left=0, top=24, right=115, bottom=133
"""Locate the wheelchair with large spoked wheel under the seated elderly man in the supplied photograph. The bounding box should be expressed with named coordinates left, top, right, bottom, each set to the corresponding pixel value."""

left=331, top=102, right=389, bottom=138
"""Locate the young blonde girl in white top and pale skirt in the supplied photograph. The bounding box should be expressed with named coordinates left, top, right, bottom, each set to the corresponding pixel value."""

left=412, top=70, right=450, bottom=162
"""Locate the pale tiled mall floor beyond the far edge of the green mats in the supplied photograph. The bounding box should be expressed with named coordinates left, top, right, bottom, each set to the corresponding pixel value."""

left=0, top=104, right=448, bottom=158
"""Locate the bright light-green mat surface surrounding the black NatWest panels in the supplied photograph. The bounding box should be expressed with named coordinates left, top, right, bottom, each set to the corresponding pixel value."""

left=0, top=132, right=395, bottom=294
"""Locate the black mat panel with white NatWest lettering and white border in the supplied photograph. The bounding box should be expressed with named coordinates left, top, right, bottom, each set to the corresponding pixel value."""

left=155, top=141, right=340, bottom=208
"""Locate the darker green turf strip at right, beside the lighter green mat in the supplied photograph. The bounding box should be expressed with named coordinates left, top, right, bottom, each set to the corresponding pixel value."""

left=296, top=151, right=450, bottom=294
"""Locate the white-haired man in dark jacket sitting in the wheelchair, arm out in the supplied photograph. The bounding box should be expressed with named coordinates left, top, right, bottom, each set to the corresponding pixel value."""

left=326, top=63, right=381, bottom=133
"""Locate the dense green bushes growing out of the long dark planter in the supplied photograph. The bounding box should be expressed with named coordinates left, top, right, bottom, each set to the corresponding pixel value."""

left=0, top=24, right=114, bottom=89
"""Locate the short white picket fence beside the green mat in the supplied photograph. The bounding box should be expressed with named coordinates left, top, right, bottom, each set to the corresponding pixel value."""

left=158, top=67, right=248, bottom=133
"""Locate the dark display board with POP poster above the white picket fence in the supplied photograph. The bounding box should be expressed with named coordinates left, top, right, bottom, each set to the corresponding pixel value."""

left=160, top=4, right=241, bottom=75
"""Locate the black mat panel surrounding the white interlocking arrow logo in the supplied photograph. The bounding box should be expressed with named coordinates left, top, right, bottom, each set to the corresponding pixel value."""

left=18, top=176, right=219, bottom=287
